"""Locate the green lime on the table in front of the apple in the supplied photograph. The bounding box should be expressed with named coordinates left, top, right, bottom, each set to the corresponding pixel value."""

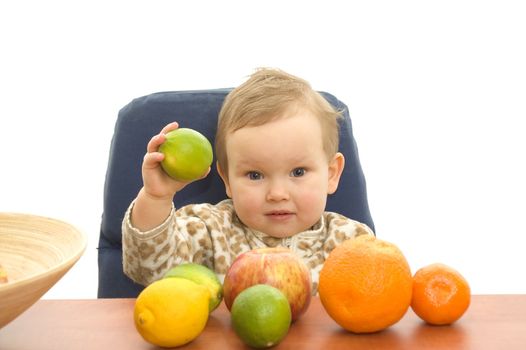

left=231, top=284, right=291, bottom=348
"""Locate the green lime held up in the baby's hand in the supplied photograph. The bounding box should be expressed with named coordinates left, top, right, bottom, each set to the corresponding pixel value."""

left=159, top=128, right=213, bottom=182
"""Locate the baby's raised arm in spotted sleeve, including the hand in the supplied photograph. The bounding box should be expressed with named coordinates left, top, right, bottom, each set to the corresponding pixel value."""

left=122, top=122, right=211, bottom=285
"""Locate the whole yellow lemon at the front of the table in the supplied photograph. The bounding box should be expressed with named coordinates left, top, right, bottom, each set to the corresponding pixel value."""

left=133, top=278, right=210, bottom=347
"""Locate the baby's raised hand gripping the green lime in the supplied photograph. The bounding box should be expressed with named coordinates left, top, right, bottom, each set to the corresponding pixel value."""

left=142, top=122, right=210, bottom=200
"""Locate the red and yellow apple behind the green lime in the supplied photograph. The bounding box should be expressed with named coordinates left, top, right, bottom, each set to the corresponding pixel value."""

left=223, top=247, right=312, bottom=321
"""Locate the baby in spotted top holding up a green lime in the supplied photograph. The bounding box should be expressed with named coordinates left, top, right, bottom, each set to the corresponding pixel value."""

left=122, top=69, right=374, bottom=295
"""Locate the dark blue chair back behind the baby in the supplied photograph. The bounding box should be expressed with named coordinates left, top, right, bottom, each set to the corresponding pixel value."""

left=98, top=89, right=374, bottom=298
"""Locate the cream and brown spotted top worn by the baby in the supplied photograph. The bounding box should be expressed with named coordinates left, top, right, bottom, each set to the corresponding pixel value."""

left=122, top=199, right=374, bottom=295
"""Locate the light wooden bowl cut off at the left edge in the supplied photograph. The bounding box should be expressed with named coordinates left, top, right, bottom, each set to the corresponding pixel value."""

left=0, top=213, right=87, bottom=328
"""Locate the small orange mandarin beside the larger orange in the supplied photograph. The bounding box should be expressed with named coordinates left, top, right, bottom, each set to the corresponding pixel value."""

left=411, top=263, right=471, bottom=325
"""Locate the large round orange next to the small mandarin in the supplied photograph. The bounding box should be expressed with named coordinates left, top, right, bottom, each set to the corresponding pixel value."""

left=318, top=236, right=413, bottom=333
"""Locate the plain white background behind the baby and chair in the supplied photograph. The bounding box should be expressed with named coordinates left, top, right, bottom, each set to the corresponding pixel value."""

left=0, top=0, right=526, bottom=298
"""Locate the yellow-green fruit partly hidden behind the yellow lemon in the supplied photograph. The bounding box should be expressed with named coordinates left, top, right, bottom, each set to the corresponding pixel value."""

left=164, top=263, right=223, bottom=312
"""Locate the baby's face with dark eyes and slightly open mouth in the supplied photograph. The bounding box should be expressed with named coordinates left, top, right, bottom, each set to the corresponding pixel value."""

left=221, top=110, right=343, bottom=237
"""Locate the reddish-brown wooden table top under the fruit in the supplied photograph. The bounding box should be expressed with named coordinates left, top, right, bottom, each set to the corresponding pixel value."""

left=0, top=295, right=526, bottom=350
